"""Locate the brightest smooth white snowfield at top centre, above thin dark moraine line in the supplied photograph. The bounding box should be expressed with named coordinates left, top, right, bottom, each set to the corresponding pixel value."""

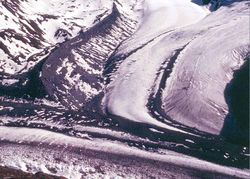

left=123, top=0, right=209, bottom=46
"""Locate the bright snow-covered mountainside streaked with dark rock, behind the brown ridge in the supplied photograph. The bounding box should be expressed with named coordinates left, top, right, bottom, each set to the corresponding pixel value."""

left=0, top=0, right=112, bottom=75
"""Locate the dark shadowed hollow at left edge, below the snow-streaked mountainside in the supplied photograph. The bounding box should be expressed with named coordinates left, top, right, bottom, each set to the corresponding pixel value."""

left=0, top=47, right=56, bottom=99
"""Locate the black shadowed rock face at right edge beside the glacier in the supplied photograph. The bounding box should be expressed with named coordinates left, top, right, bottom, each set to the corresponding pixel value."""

left=221, top=58, right=249, bottom=146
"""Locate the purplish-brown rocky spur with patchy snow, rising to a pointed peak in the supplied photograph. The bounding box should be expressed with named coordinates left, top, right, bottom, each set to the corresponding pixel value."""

left=41, top=4, right=137, bottom=110
